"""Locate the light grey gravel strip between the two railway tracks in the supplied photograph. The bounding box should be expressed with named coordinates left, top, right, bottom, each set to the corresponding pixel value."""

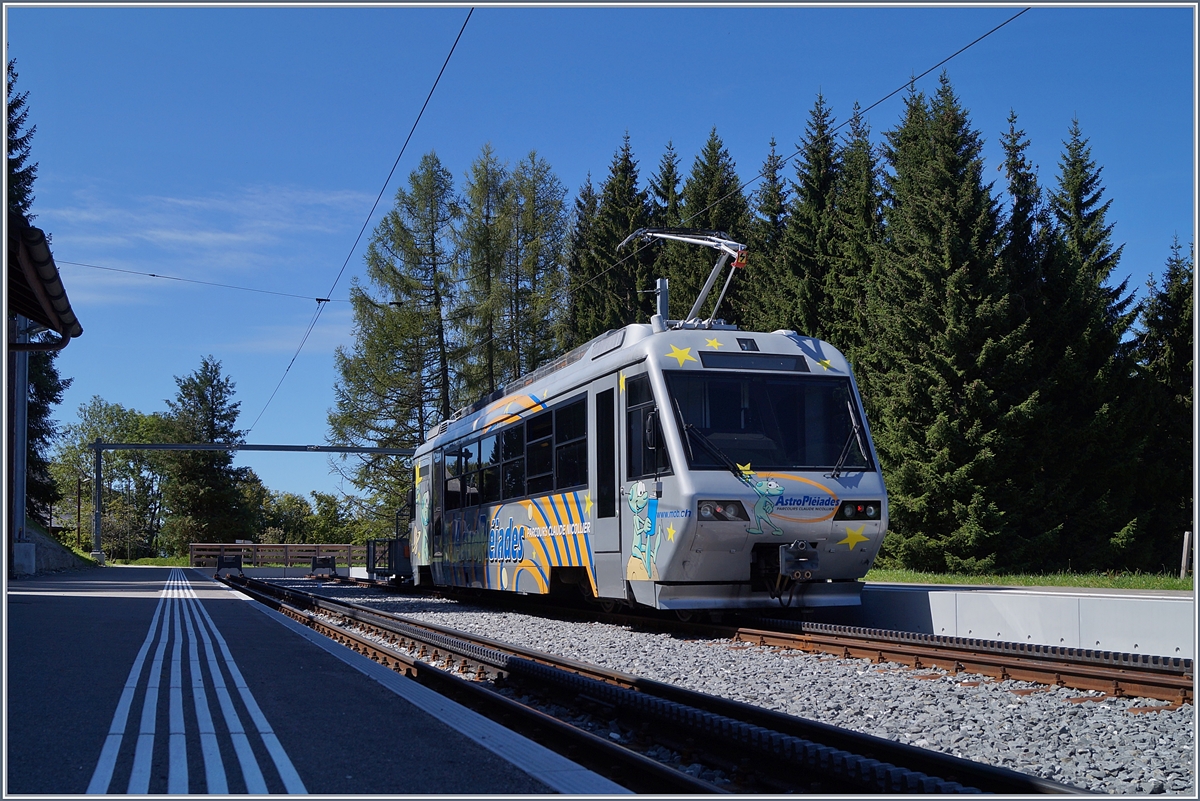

left=270, top=579, right=1196, bottom=796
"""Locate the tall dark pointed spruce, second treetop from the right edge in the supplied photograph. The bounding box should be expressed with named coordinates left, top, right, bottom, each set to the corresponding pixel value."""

left=1026, top=120, right=1141, bottom=570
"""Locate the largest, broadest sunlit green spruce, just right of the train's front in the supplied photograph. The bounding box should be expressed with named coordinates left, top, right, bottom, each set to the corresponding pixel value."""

left=869, top=74, right=1024, bottom=571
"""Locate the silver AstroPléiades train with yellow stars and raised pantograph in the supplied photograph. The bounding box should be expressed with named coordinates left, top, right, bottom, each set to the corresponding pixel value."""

left=408, top=228, right=888, bottom=609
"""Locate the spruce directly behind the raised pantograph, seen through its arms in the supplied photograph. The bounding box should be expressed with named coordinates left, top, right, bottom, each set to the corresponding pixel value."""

left=670, top=126, right=750, bottom=323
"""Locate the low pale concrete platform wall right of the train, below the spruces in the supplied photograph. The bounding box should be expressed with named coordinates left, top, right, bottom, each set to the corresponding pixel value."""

left=812, top=583, right=1196, bottom=658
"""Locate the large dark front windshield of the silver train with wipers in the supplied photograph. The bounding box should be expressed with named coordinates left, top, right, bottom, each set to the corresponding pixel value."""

left=664, top=371, right=874, bottom=472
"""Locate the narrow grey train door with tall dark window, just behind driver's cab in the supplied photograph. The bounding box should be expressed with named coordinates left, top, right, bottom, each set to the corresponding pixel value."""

left=589, top=374, right=625, bottom=598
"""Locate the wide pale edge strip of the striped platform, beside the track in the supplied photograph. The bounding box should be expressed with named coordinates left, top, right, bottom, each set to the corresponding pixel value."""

left=246, top=594, right=630, bottom=795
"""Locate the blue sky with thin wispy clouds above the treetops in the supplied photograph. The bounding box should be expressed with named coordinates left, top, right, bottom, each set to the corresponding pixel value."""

left=5, top=5, right=1195, bottom=494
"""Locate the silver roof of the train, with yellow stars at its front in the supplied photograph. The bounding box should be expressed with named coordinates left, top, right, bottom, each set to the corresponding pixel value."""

left=425, top=324, right=851, bottom=444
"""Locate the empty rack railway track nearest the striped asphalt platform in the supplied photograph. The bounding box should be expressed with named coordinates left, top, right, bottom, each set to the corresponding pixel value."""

left=222, top=577, right=1081, bottom=794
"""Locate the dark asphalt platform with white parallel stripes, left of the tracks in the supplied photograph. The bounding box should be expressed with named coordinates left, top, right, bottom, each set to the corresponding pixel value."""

left=4, top=567, right=625, bottom=796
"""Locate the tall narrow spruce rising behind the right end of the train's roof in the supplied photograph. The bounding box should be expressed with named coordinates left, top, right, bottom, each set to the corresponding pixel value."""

left=784, top=94, right=841, bottom=338
